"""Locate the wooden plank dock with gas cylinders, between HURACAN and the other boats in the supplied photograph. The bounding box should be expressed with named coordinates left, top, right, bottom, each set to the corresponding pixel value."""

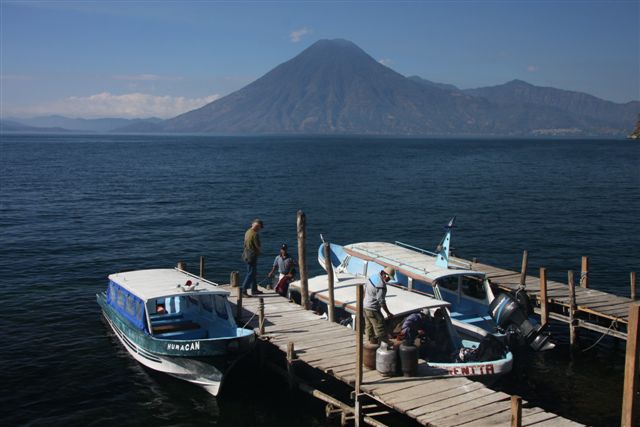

left=230, top=288, right=580, bottom=427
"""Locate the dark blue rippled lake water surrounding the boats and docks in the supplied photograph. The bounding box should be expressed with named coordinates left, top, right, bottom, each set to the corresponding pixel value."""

left=0, top=135, right=640, bottom=426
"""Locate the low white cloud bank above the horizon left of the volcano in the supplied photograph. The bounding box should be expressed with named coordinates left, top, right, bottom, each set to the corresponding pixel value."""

left=5, top=92, right=220, bottom=119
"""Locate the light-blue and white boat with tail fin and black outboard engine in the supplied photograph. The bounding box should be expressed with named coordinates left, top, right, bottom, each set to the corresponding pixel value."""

left=318, top=218, right=555, bottom=351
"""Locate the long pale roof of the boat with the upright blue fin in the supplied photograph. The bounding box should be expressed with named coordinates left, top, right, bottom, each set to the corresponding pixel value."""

left=344, top=242, right=485, bottom=283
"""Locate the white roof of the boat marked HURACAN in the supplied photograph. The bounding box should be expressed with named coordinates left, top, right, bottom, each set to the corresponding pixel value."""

left=109, top=268, right=229, bottom=302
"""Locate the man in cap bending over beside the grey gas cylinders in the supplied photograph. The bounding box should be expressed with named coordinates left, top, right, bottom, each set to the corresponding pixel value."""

left=363, top=267, right=396, bottom=344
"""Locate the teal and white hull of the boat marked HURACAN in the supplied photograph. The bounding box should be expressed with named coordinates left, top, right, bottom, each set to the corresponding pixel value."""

left=97, top=294, right=255, bottom=396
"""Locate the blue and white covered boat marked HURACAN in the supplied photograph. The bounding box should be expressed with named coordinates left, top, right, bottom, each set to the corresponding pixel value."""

left=96, top=269, right=255, bottom=396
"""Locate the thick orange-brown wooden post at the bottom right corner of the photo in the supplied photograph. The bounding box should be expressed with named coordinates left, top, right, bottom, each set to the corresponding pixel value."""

left=620, top=304, right=640, bottom=427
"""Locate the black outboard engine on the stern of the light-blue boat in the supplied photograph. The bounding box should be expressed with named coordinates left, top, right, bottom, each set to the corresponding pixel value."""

left=489, top=291, right=555, bottom=351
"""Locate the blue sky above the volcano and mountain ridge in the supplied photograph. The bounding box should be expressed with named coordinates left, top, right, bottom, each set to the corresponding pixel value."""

left=0, top=0, right=640, bottom=117
